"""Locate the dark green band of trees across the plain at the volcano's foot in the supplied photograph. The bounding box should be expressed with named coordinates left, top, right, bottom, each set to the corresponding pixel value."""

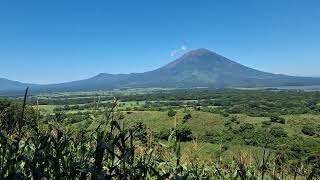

left=30, top=90, right=320, bottom=116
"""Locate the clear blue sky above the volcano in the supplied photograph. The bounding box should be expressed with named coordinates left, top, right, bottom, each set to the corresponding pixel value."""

left=0, top=0, right=320, bottom=83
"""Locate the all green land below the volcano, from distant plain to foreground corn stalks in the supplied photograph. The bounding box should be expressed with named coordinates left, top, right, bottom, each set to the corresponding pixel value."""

left=0, top=90, right=320, bottom=179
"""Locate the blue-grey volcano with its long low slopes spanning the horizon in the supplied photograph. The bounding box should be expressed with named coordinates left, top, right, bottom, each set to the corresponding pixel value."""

left=0, top=48, right=320, bottom=92
